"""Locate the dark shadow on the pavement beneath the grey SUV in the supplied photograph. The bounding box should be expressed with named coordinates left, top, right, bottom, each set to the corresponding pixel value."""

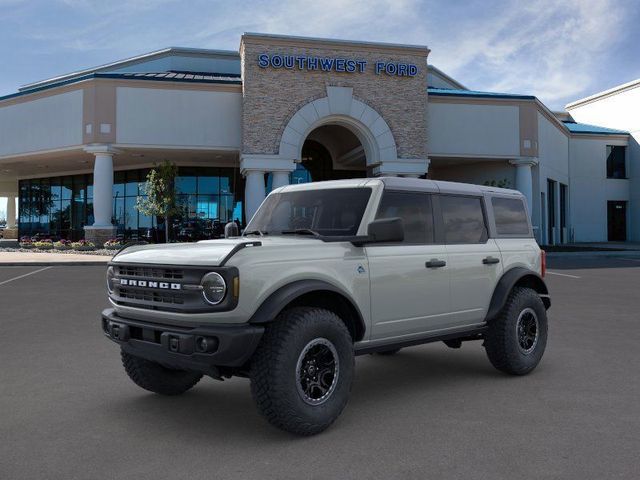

left=102, top=346, right=507, bottom=442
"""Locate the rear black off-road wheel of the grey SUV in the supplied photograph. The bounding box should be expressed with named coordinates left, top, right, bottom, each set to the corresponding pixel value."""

left=485, top=287, right=547, bottom=375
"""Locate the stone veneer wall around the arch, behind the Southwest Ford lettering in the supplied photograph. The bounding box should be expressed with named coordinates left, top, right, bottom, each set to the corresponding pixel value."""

left=240, top=37, right=428, bottom=159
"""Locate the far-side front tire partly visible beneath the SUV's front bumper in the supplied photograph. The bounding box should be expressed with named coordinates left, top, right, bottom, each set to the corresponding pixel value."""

left=120, top=350, right=202, bottom=395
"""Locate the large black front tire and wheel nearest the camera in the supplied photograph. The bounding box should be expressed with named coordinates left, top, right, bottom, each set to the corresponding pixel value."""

left=250, top=307, right=354, bottom=435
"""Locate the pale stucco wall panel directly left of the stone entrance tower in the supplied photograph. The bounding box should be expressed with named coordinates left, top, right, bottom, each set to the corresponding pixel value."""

left=116, top=87, right=242, bottom=149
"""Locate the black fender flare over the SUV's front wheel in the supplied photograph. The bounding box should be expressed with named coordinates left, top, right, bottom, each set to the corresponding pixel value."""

left=249, top=280, right=366, bottom=341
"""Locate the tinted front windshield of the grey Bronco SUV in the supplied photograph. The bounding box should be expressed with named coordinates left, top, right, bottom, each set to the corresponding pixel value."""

left=244, top=188, right=371, bottom=236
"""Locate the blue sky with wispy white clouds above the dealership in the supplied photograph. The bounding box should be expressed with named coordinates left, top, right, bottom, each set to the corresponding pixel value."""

left=0, top=0, right=640, bottom=217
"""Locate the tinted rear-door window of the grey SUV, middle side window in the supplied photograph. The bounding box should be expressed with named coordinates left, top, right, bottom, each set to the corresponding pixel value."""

left=440, top=195, right=488, bottom=244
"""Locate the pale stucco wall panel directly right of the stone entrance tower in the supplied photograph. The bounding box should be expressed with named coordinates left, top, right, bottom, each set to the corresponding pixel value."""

left=427, top=101, right=520, bottom=158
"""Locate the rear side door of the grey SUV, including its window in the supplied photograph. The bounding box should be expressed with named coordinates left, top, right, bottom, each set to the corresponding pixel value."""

left=437, top=194, right=503, bottom=327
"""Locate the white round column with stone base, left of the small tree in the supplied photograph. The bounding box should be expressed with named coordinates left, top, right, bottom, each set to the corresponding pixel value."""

left=84, top=145, right=118, bottom=247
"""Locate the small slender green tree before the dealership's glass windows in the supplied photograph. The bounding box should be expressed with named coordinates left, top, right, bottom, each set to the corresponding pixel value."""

left=136, top=160, right=180, bottom=243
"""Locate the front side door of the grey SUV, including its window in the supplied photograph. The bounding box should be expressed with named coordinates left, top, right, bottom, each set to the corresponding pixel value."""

left=366, top=191, right=450, bottom=340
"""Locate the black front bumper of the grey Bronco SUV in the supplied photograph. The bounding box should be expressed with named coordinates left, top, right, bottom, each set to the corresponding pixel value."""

left=102, top=308, right=264, bottom=375
